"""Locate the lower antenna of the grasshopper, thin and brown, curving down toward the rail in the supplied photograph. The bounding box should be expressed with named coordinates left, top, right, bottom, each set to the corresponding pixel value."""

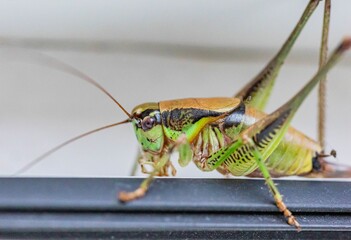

left=12, top=119, right=130, bottom=176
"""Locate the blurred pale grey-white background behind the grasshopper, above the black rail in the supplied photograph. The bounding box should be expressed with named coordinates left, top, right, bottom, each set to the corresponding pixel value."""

left=0, top=0, right=351, bottom=177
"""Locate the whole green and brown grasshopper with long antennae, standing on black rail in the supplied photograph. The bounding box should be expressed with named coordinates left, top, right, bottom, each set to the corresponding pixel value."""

left=13, top=0, right=351, bottom=230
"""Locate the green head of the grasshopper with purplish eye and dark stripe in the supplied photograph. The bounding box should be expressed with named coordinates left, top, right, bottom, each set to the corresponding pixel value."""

left=132, top=103, right=164, bottom=154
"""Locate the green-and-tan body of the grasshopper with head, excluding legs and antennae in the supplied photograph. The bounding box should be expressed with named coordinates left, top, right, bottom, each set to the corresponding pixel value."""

left=133, top=98, right=321, bottom=176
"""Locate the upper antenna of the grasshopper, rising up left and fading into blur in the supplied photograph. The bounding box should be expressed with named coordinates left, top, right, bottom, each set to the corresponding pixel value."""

left=15, top=52, right=132, bottom=118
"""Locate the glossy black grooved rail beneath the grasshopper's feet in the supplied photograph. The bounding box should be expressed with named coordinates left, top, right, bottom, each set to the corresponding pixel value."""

left=0, top=178, right=351, bottom=239
